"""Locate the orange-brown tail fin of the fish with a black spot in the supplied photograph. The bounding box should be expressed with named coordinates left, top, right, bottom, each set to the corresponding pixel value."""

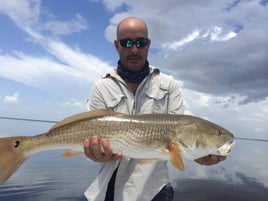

left=0, top=137, right=28, bottom=184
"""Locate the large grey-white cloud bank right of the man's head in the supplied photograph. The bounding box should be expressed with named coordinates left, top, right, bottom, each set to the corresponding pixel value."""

left=101, top=0, right=268, bottom=104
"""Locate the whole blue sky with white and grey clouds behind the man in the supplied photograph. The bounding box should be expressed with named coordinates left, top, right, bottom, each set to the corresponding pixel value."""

left=0, top=0, right=268, bottom=143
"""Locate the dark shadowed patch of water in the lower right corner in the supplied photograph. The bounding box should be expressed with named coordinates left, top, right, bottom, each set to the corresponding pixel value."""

left=175, top=175, right=268, bottom=201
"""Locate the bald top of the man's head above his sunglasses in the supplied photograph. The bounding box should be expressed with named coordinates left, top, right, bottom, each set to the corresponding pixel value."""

left=117, top=17, right=148, bottom=39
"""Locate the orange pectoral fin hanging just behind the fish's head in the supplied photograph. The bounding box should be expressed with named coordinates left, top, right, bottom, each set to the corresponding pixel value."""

left=169, top=144, right=184, bottom=170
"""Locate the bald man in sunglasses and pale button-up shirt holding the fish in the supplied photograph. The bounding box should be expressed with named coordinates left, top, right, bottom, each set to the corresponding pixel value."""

left=84, top=17, right=225, bottom=201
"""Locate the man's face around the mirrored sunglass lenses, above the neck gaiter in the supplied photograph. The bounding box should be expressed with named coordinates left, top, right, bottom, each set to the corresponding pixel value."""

left=114, top=23, right=151, bottom=71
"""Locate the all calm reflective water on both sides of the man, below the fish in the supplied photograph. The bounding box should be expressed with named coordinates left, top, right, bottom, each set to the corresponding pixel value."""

left=0, top=141, right=268, bottom=201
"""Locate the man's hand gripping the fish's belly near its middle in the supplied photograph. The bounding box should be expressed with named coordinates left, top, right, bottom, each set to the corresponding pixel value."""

left=84, top=136, right=122, bottom=162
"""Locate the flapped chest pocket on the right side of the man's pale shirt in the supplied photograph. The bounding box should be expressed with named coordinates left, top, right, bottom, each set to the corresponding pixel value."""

left=145, top=82, right=169, bottom=113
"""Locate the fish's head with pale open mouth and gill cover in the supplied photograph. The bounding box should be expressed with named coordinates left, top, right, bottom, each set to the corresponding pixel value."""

left=174, top=115, right=234, bottom=159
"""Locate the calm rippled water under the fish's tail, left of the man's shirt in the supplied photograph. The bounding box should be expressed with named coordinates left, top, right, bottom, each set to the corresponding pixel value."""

left=0, top=151, right=95, bottom=201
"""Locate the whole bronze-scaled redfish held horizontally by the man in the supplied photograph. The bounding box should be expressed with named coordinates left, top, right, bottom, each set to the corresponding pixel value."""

left=0, top=110, right=234, bottom=184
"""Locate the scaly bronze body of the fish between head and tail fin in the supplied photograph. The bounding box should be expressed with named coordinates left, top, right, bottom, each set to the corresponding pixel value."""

left=17, top=115, right=176, bottom=158
